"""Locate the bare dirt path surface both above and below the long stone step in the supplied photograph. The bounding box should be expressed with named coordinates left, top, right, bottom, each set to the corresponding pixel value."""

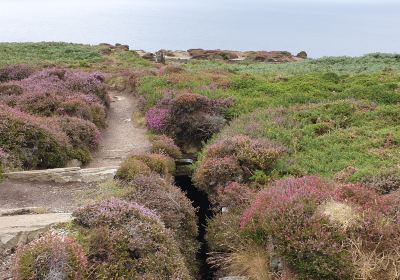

left=0, top=92, right=150, bottom=212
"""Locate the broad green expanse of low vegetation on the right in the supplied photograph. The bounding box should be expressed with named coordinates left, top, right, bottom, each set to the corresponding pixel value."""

left=138, top=54, right=400, bottom=181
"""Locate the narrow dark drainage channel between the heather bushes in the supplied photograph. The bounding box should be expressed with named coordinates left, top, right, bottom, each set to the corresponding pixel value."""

left=175, top=176, right=213, bottom=280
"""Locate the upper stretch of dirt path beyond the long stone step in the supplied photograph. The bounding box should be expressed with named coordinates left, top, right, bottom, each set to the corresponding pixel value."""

left=87, top=92, right=150, bottom=168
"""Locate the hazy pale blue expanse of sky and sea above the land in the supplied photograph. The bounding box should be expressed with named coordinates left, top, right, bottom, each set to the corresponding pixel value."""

left=0, top=0, right=400, bottom=57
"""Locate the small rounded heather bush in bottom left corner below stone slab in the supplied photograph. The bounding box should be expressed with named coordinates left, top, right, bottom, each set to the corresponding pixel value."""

left=14, top=233, right=88, bottom=280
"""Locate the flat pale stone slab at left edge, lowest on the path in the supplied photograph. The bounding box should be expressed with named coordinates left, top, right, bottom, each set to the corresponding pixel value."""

left=0, top=213, right=72, bottom=249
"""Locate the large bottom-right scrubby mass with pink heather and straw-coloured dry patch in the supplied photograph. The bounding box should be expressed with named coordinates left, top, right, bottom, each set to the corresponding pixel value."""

left=241, top=177, right=400, bottom=279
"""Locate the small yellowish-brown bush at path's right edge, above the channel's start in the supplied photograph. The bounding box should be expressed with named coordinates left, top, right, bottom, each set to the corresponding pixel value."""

left=131, top=154, right=176, bottom=176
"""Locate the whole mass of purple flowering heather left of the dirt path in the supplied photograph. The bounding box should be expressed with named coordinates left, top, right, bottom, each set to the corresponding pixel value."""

left=0, top=66, right=109, bottom=168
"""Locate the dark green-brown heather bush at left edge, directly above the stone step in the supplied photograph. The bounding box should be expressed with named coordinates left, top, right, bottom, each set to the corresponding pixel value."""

left=0, top=104, right=71, bottom=168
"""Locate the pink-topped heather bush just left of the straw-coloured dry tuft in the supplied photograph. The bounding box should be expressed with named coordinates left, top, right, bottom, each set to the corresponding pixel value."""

left=241, top=177, right=353, bottom=279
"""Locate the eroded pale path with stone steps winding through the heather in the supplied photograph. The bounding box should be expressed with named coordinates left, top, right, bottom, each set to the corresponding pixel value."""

left=0, top=92, right=150, bottom=274
